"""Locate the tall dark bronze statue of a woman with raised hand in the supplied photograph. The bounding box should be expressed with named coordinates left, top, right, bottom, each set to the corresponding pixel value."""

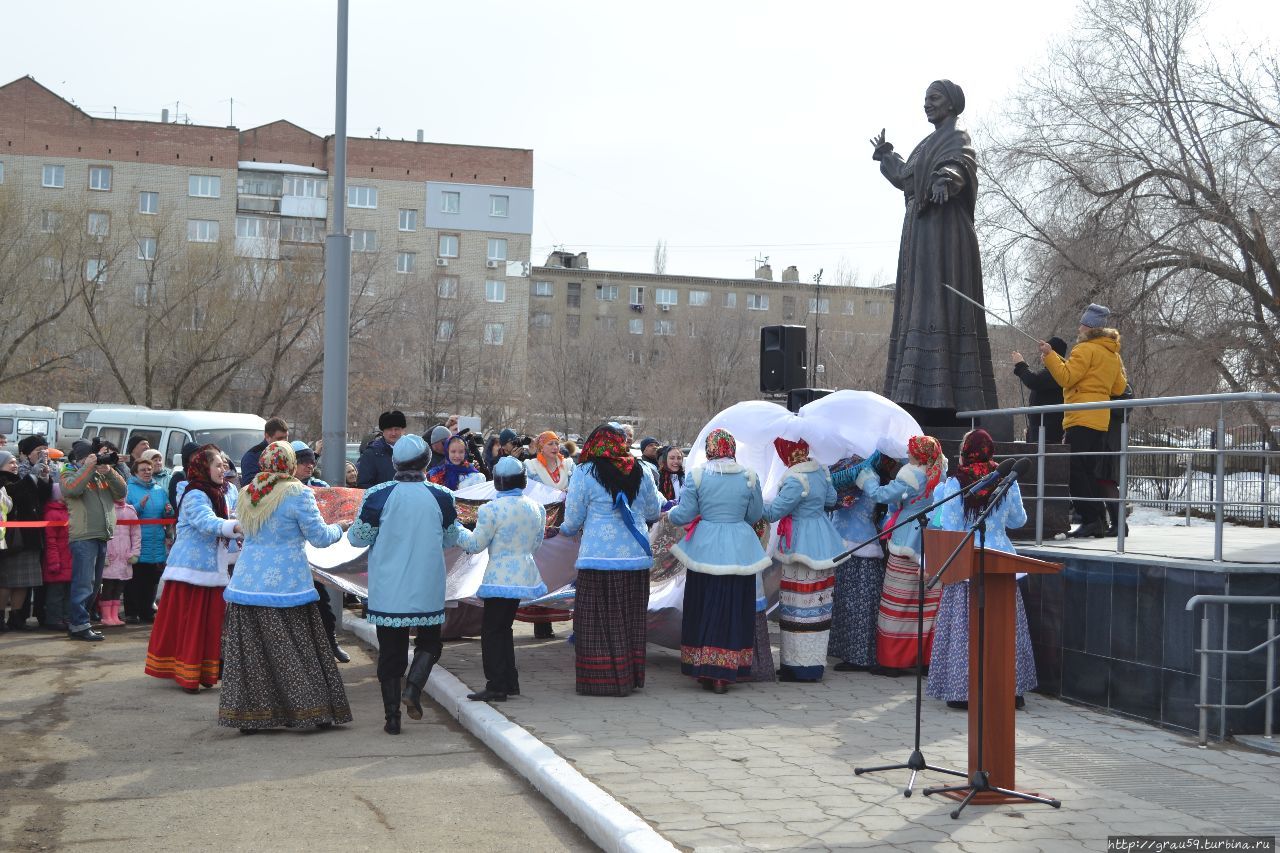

left=870, top=79, right=996, bottom=427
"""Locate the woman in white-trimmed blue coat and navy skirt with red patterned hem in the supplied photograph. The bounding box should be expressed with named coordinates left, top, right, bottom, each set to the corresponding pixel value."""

left=667, top=429, right=772, bottom=693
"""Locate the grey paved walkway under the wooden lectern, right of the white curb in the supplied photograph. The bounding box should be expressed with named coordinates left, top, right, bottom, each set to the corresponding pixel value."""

left=443, top=624, right=1280, bottom=853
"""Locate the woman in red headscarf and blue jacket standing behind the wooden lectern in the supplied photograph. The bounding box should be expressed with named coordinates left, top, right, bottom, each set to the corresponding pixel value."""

left=925, top=429, right=1036, bottom=708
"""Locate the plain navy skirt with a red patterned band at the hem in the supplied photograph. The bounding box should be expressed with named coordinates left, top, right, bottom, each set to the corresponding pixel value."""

left=680, top=570, right=755, bottom=683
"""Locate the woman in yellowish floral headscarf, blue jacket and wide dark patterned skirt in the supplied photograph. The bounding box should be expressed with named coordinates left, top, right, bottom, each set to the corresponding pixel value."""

left=218, top=442, right=351, bottom=734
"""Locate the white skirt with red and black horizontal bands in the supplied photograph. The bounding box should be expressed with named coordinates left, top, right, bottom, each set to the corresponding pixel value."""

left=778, top=562, right=836, bottom=681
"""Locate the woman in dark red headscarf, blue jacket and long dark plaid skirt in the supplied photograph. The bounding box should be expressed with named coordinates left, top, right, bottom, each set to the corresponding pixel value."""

left=561, top=424, right=662, bottom=695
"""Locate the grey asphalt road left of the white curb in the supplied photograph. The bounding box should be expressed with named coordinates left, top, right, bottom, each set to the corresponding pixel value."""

left=0, top=628, right=596, bottom=853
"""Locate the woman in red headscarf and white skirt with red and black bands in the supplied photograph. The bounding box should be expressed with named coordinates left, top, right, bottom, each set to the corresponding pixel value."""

left=764, top=438, right=845, bottom=681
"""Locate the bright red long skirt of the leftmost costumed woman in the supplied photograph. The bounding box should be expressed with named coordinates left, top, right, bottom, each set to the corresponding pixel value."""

left=143, top=580, right=227, bottom=688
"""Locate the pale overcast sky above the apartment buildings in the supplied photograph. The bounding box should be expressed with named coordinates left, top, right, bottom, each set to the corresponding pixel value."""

left=0, top=0, right=1276, bottom=282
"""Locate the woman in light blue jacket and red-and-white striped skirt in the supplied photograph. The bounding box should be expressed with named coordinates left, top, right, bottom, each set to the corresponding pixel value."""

left=869, top=435, right=947, bottom=676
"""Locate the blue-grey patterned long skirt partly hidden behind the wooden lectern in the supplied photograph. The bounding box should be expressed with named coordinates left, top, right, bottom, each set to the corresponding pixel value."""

left=925, top=580, right=1036, bottom=702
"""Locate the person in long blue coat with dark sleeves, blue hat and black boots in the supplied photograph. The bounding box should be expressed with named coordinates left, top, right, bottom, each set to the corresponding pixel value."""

left=347, top=434, right=462, bottom=734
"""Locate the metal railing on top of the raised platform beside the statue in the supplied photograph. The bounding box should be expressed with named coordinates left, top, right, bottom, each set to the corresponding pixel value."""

left=957, top=392, right=1280, bottom=562
